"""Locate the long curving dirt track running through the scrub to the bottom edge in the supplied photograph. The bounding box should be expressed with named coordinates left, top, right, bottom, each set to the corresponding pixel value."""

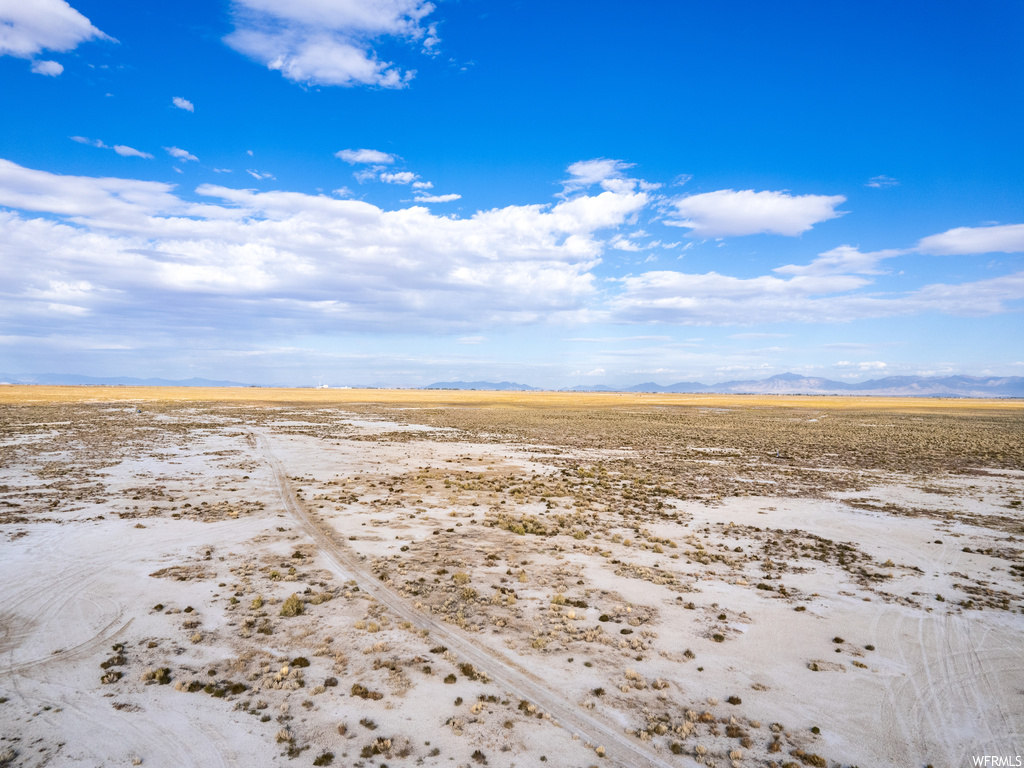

left=257, top=435, right=696, bottom=768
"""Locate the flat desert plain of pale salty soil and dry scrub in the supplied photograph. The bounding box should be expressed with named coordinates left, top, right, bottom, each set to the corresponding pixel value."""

left=0, top=387, right=1024, bottom=768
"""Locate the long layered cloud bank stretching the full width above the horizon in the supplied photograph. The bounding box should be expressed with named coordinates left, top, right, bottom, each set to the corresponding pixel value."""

left=0, top=156, right=1024, bottom=354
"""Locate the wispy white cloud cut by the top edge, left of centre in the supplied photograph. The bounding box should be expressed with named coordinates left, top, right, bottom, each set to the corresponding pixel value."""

left=224, top=0, right=439, bottom=88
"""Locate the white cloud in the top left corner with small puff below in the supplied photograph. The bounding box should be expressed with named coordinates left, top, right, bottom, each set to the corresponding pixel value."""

left=0, top=0, right=113, bottom=60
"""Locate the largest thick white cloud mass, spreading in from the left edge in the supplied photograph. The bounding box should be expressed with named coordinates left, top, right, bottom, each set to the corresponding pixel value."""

left=0, top=155, right=648, bottom=338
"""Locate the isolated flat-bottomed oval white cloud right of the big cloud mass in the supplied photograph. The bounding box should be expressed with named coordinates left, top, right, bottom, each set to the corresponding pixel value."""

left=665, top=189, right=846, bottom=238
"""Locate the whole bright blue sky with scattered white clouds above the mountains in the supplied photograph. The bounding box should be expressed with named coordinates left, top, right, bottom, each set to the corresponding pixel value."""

left=0, top=0, right=1024, bottom=387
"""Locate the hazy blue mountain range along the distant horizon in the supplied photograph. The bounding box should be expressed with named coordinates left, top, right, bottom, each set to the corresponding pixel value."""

left=8, top=374, right=1024, bottom=397
